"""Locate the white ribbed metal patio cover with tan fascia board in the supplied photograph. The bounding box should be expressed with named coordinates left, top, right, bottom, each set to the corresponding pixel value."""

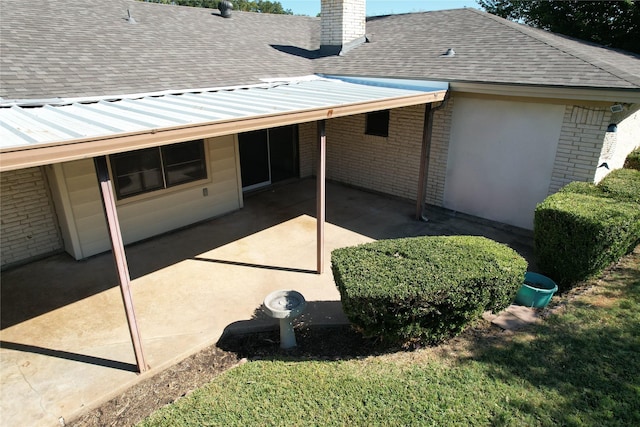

left=0, top=76, right=448, bottom=171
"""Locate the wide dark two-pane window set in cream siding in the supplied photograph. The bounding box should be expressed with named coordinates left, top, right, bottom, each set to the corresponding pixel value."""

left=109, top=140, right=207, bottom=200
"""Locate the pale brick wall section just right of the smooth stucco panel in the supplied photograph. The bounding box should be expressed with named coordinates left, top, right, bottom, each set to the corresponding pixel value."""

left=549, top=105, right=611, bottom=194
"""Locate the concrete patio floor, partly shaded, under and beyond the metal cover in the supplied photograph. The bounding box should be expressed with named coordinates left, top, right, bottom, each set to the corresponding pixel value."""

left=0, top=180, right=535, bottom=426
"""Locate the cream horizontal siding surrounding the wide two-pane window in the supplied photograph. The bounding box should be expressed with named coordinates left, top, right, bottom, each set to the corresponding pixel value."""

left=47, top=135, right=242, bottom=259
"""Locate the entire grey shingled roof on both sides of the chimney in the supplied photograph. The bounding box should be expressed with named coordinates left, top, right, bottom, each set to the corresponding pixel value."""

left=0, top=0, right=640, bottom=99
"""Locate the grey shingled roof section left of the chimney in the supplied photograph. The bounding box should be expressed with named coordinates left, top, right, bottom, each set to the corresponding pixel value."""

left=0, top=0, right=320, bottom=99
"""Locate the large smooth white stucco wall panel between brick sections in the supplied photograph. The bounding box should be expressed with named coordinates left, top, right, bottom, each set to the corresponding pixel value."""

left=444, top=97, right=565, bottom=229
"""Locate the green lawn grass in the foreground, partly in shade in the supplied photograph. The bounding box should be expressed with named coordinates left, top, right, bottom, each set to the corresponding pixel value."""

left=140, top=247, right=640, bottom=426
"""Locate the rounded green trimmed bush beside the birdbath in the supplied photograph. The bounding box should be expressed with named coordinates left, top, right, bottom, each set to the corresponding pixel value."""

left=331, top=236, right=527, bottom=346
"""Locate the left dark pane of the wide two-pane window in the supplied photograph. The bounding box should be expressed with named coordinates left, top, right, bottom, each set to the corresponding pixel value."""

left=110, top=148, right=164, bottom=199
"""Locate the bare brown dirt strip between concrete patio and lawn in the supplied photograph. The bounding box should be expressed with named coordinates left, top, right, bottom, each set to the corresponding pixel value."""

left=67, top=322, right=507, bottom=427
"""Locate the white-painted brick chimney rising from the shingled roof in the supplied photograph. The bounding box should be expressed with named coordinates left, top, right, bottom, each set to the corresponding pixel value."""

left=320, top=0, right=367, bottom=55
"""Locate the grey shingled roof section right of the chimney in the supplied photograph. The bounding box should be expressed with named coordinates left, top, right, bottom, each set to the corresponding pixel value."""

left=316, top=8, right=640, bottom=89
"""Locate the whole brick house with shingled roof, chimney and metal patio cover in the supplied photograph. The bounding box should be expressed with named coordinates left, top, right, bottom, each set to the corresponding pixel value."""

left=0, top=0, right=640, bottom=268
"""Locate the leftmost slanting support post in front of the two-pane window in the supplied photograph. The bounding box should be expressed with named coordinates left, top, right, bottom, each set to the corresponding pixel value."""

left=93, top=156, right=148, bottom=373
